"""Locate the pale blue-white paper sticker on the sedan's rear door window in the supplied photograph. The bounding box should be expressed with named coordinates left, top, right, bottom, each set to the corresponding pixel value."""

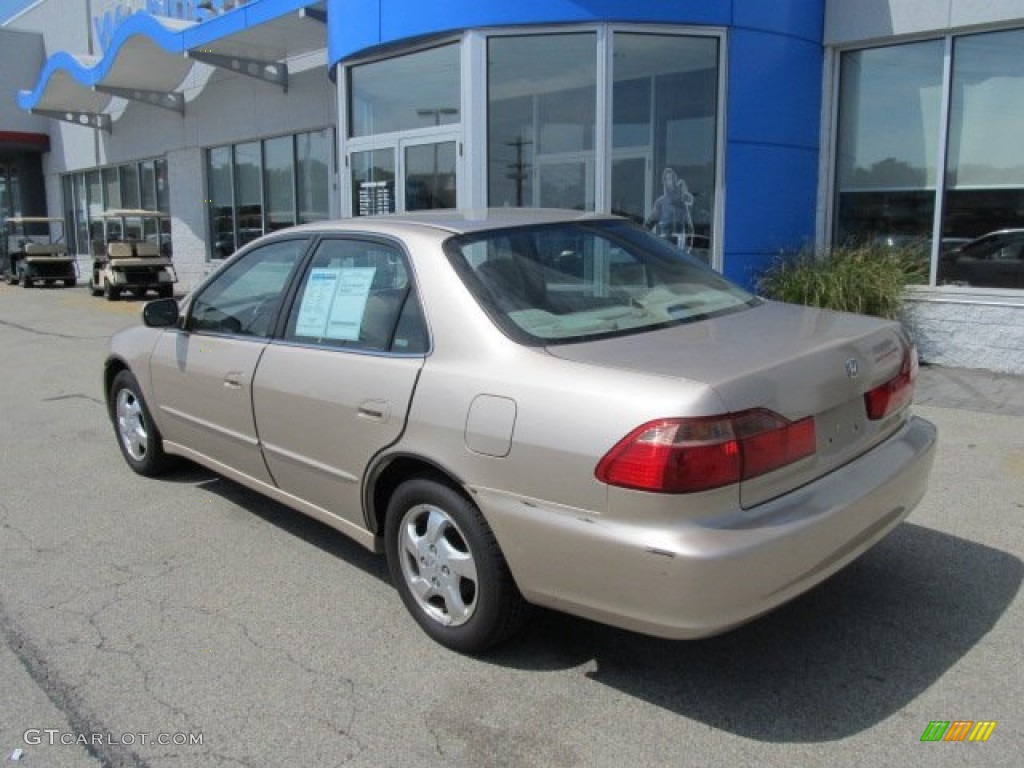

left=295, top=266, right=377, bottom=341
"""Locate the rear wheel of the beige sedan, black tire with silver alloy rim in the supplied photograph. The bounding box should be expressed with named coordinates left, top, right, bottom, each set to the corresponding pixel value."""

left=385, top=477, right=529, bottom=653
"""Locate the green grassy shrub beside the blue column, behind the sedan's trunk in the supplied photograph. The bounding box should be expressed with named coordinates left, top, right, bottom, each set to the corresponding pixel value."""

left=757, top=244, right=928, bottom=319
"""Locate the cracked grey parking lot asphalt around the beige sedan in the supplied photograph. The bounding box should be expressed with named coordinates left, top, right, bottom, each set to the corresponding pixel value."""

left=0, top=285, right=1024, bottom=768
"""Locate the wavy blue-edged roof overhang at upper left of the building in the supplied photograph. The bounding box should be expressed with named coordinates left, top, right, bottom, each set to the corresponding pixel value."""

left=17, top=0, right=327, bottom=130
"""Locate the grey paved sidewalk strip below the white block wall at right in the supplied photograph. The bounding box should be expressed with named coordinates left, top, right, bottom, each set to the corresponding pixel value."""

left=913, top=366, right=1024, bottom=417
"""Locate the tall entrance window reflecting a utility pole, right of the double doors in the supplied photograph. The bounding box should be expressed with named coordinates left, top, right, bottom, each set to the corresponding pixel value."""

left=487, top=33, right=597, bottom=210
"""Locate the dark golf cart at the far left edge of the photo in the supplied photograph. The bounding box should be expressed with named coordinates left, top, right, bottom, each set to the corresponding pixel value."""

left=0, top=216, right=78, bottom=288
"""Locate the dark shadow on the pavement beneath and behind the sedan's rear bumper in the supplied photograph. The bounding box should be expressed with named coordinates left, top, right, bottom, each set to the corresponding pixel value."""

left=489, top=523, right=1024, bottom=742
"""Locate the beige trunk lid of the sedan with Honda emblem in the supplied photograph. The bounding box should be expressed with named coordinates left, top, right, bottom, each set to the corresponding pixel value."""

left=549, top=302, right=907, bottom=507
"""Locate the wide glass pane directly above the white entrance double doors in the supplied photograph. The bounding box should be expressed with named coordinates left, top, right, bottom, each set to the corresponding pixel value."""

left=349, top=44, right=462, bottom=137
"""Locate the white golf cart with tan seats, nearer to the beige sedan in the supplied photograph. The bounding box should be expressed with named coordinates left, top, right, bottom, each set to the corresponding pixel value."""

left=89, top=209, right=178, bottom=301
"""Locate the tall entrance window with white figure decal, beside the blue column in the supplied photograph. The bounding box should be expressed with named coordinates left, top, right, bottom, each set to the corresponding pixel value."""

left=611, top=33, right=719, bottom=262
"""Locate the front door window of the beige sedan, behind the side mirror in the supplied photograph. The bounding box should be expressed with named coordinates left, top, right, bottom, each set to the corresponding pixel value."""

left=187, top=238, right=308, bottom=338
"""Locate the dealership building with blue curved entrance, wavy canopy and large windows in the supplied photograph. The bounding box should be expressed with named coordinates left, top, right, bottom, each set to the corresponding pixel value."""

left=0, top=0, right=1024, bottom=374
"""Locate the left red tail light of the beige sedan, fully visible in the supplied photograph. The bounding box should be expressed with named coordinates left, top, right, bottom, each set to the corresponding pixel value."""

left=595, top=409, right=816, bottom=494
